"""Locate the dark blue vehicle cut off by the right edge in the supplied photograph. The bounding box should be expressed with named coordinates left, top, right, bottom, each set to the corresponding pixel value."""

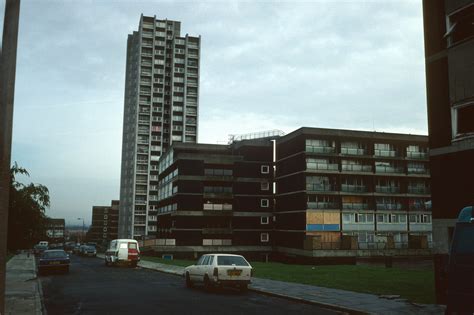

left=446, top=206, right=474, bottom=314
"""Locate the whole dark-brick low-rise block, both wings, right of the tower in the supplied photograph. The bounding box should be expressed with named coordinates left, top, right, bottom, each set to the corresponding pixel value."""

left=142, top=128, right=432, bottom=259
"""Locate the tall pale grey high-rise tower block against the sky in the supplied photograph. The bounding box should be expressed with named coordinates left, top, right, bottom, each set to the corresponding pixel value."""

left=119, top=15, right=201, bottom=238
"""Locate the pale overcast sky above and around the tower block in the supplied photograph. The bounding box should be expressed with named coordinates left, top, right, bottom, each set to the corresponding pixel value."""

left=0, top=0, right=427, bottom=224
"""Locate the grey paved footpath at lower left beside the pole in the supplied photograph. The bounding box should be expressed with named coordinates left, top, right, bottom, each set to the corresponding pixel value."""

left=5, top=253, right=43, bottom=315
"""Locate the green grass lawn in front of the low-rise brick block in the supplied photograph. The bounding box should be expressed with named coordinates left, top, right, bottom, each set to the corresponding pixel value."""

left=142, top=257, right=435, bottom=304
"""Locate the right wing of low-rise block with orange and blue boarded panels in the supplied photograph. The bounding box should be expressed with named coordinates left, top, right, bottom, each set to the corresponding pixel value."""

left=274, top=128, right=432, bottom=256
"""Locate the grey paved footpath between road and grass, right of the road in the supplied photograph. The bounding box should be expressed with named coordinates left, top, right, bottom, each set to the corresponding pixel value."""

left=98, top=255, right=445, bottom=314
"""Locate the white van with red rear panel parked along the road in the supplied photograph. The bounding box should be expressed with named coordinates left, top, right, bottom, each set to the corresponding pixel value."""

left=105, top=239, right=140, bottom=267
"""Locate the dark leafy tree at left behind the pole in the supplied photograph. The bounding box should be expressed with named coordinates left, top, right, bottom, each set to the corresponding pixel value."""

left=7, top=162, right=50, bottom=250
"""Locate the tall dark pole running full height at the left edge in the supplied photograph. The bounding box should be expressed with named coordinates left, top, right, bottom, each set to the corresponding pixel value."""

left=0, top=0, right=20, bottom=314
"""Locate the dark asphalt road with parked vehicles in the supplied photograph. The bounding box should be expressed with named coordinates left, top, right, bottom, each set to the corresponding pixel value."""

left=40, top=255, right=340, bottom=315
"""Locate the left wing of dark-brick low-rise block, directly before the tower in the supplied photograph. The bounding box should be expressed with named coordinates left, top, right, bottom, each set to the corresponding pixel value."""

left=153, top=139, right=273, bottom=256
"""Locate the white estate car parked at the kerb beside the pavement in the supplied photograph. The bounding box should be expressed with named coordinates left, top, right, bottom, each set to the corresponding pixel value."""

left=184, top=254, right=253, bottom=291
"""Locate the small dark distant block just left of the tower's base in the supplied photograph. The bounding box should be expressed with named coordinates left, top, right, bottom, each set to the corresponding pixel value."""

left=87, top=200, right=120, bottom=245
